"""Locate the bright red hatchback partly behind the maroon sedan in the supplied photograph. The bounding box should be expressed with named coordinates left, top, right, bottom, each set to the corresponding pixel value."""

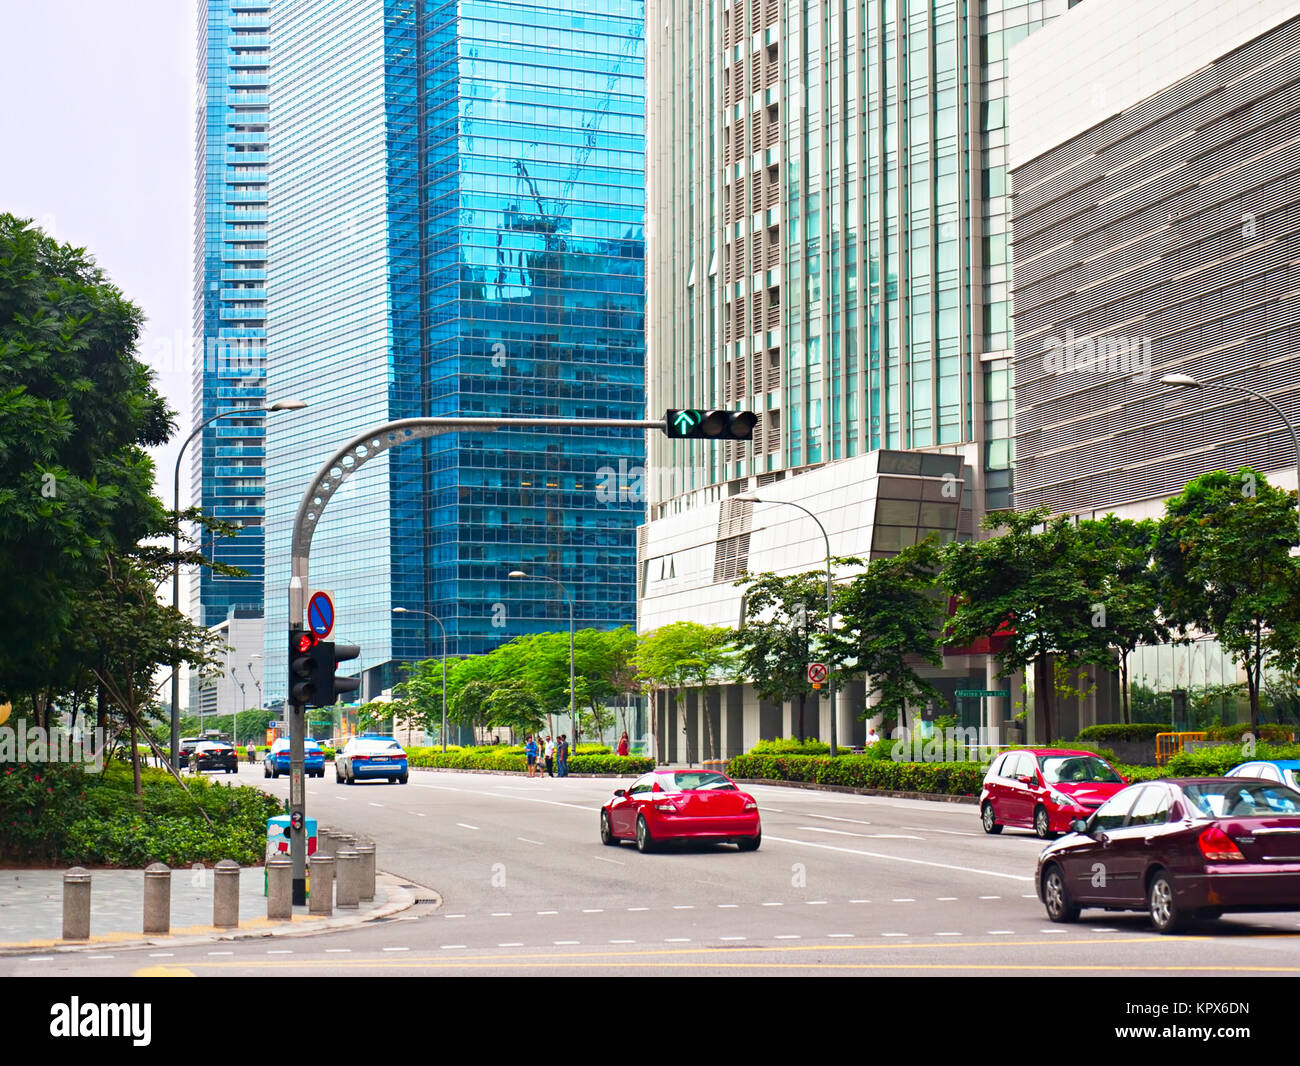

left=979, top=748, right=1127, bottom=840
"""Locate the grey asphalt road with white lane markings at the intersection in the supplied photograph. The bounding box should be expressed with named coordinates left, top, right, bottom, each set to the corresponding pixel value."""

left=15, top=768, right=1300, bottom=977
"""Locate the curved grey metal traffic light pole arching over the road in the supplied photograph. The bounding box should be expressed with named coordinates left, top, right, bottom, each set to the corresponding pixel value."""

left=287, top=416, right=671, bottom=906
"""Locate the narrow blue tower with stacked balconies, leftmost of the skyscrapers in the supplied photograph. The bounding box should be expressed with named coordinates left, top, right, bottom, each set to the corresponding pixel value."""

left=190, top=0, right=270, bottom=625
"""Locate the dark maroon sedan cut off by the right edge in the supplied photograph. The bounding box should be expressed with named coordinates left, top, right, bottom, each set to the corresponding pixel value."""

left=1035, top=777, right=1300, bottom=933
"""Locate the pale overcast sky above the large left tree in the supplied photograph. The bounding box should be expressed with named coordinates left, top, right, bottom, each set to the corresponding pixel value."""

left=0, top=0, right=195, bottom=506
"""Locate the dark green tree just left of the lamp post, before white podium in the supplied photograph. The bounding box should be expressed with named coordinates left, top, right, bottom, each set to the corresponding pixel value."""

left=735, top=571, right=835, bottom=741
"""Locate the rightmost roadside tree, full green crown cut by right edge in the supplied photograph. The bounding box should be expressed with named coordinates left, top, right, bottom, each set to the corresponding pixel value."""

left=1154, top=467, right=1300, bottom=729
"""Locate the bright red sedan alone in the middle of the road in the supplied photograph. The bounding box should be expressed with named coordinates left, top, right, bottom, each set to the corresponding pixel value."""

left=601, top=770, right=763, bottom=852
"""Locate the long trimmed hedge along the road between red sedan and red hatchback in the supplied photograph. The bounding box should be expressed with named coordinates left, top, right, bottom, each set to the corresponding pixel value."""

left=727, top=754, right=987, bottom=796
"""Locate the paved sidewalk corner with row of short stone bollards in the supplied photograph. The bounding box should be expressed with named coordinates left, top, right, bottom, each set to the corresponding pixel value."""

left=0, top=866, right=421, bottom=956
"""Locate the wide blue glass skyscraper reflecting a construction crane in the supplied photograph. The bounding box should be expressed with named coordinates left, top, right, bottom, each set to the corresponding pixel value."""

left=265, top=0, right=645, bottom=699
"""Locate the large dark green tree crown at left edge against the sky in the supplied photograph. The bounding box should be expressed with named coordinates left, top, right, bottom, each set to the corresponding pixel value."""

left=0, top=215, right=172, bottom=709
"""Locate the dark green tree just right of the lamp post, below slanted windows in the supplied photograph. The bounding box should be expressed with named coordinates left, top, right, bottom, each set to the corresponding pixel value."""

left=832, top=541, right=945, bottom=719
